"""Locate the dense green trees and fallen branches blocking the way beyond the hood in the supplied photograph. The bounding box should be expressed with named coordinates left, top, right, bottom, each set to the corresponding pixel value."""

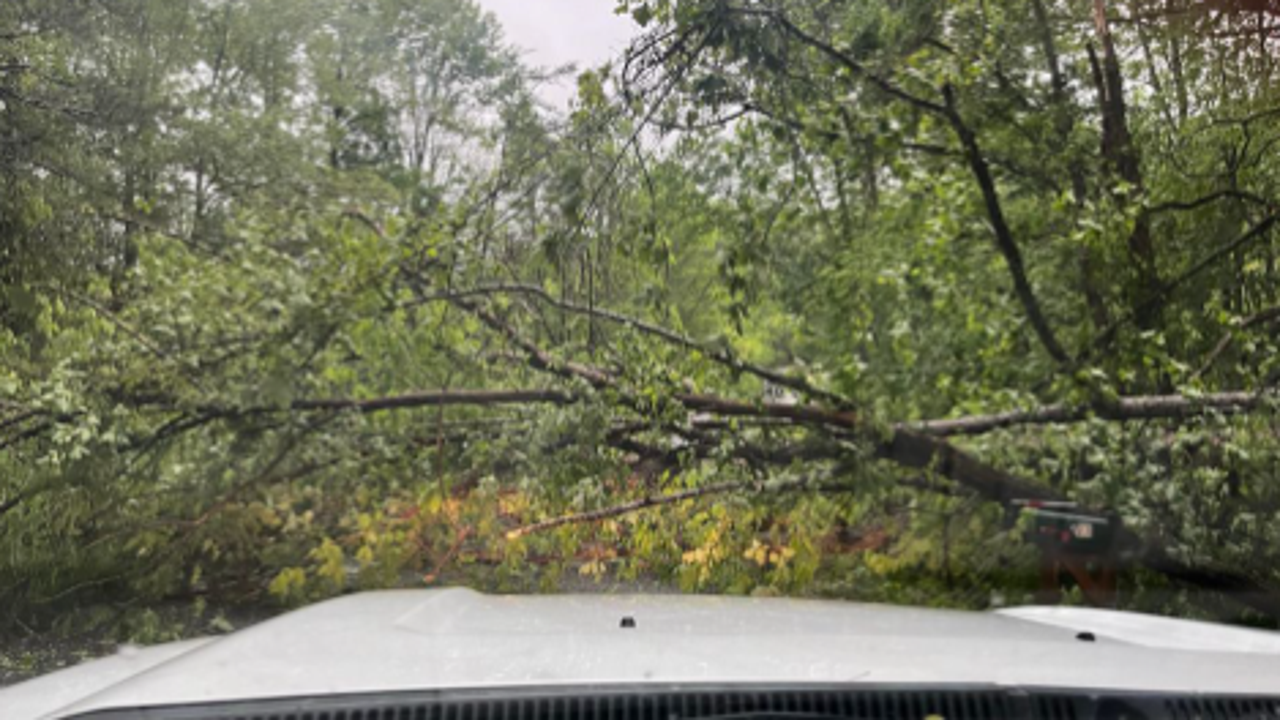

left=0, top=0, right=1280, bottom=623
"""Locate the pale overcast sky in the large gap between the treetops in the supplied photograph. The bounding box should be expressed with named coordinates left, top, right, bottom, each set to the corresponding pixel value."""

left=476, top=0, right=636, bottom=108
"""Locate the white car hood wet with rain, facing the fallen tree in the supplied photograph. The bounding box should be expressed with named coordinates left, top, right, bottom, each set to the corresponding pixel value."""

left=0, top=589, right=1280, bottom=720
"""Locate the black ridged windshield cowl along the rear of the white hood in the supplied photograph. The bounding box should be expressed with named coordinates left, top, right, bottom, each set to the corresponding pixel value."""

left=62, top=685, right=1280, bottom=720
